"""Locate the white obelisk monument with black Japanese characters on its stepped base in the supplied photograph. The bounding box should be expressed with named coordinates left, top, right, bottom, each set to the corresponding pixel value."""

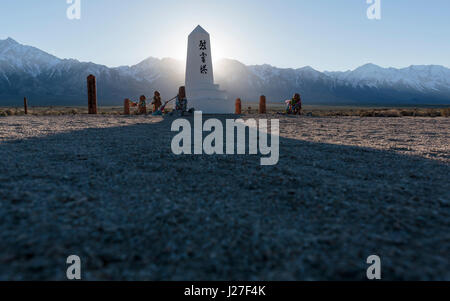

left=186, top=25, right=234, bottom=114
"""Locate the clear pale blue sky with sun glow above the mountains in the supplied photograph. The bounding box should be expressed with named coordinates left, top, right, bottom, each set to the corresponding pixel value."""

left=0, top=0, right=450, bottom=71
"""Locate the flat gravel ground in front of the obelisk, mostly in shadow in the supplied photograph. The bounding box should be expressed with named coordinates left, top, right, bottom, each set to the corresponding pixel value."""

left=0, top=115, right=450, bottom=280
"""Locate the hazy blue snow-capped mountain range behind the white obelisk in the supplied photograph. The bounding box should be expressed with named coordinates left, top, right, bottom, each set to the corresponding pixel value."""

left=0, top=38, right=450, bottom=106
